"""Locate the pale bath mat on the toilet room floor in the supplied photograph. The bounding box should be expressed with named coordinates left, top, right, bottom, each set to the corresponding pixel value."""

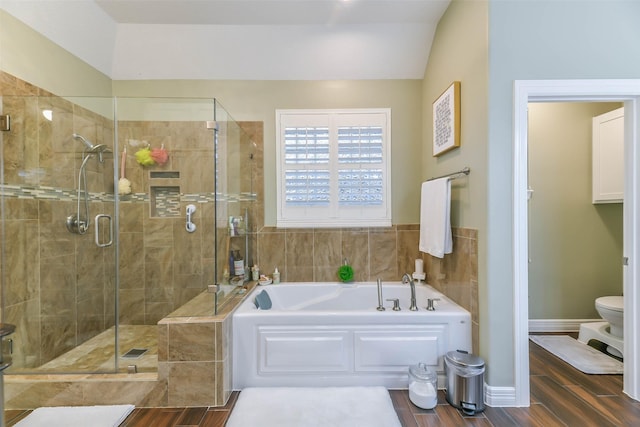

left=529, top=335, right=624, bottom=374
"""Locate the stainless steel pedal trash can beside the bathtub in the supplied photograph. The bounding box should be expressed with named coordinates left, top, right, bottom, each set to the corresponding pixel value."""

left=444, top=350, right=484, bottom=415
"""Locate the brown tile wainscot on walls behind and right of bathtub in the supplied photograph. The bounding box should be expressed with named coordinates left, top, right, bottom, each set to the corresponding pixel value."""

left=257, top=224, right=479, bottom=354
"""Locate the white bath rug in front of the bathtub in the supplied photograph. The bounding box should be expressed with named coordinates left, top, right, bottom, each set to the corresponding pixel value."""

left=226, top=387, right=401, bottom=427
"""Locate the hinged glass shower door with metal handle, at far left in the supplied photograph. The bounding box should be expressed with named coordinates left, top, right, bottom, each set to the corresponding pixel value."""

left=1, top=95, right=118, bottom=374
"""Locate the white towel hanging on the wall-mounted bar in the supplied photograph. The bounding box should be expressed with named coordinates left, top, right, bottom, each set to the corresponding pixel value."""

left=418, top=178, right=453, bottom=258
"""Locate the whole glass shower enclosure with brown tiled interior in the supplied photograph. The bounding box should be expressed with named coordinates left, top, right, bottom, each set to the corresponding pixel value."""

left=0, top=95, right=254, bottom=374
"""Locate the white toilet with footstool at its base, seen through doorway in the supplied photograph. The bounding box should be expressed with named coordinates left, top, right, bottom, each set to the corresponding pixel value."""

left=578, top=296, right=624, bottom=357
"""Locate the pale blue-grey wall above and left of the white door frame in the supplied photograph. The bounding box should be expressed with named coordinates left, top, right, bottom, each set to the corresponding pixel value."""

left=488, top=0, right=640, bottom=387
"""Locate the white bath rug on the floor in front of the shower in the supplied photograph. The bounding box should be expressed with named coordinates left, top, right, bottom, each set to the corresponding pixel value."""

left=14, top=405, right=135, bottom=427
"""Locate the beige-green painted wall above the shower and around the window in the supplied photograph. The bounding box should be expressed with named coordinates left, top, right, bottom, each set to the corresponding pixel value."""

left=0, top=10, right=422, bottom=226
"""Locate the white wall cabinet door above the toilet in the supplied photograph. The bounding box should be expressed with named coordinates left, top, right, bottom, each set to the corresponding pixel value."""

left=592, top=108, right=624, bottom=203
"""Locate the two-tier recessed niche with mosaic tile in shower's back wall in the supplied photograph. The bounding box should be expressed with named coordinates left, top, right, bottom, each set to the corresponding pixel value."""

left=149, top=171, right=180, bottom=218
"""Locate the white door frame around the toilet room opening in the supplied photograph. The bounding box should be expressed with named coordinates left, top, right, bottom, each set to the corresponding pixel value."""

left=512, top=79, right=640, bottom=406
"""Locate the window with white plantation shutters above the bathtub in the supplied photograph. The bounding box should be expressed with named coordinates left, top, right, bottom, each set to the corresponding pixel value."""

left=276, top=109, right=391, bottom=227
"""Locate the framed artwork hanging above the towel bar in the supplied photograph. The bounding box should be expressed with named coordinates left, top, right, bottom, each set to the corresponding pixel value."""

left=433, top=81, right=460, bottom=157
